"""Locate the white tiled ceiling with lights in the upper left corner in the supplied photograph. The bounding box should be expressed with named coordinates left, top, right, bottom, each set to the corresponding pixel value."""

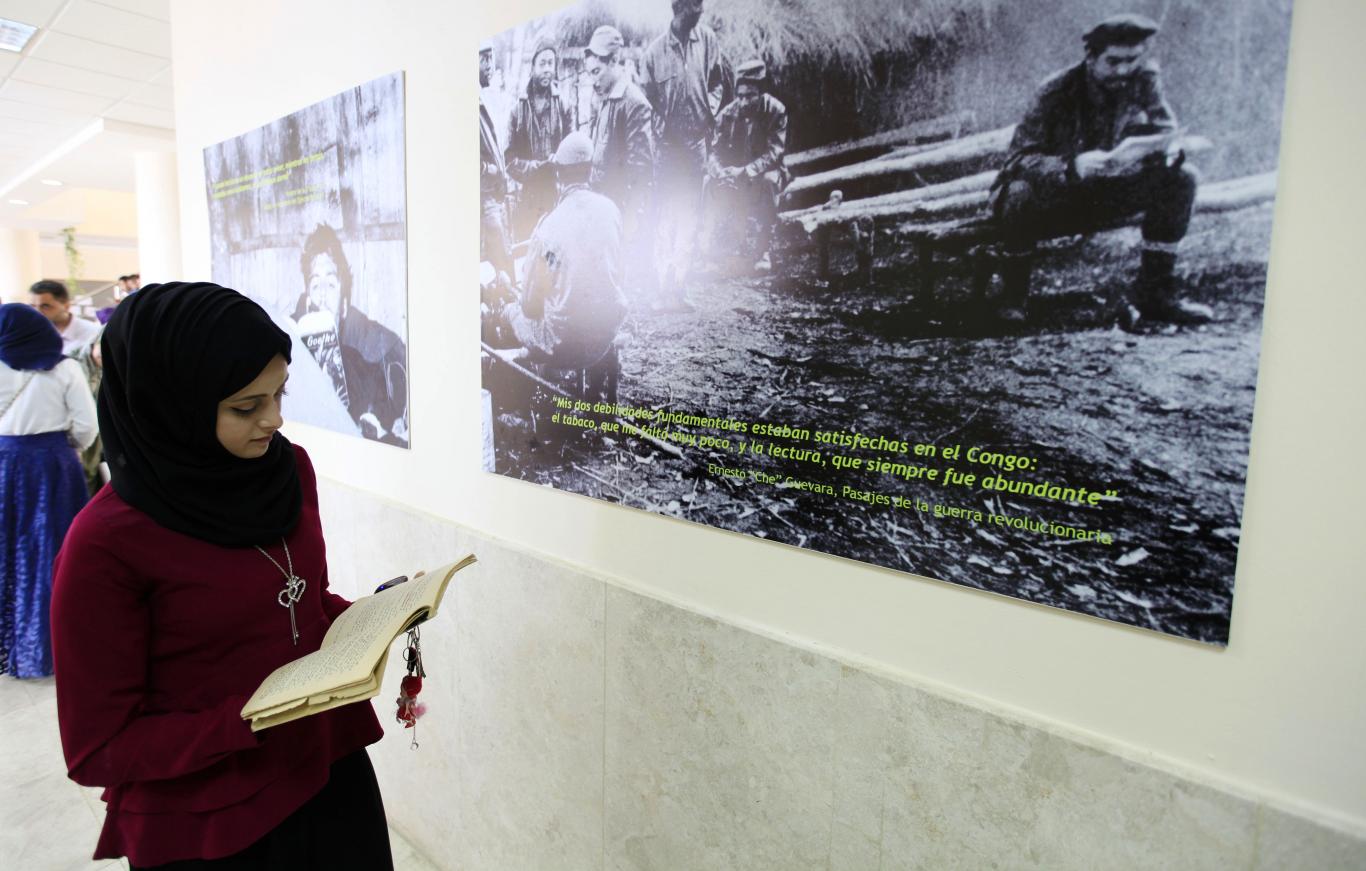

left=0, top=0, right=175, bottom=227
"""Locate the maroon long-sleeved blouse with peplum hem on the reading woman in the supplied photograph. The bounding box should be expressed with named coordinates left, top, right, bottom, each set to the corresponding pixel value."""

left=52, top=445, right=382, bottom=866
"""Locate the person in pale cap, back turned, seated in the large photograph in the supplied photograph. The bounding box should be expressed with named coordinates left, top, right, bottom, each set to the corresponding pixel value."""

left=500, top=131, right=626, bottom=390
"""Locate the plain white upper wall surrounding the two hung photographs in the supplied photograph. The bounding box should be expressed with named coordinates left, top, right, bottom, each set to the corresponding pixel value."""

left=172, top=0, right=1366, bottom=830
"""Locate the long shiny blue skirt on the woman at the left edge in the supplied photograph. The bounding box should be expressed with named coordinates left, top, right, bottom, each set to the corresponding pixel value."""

left=0, top=433, right=87, bottom=677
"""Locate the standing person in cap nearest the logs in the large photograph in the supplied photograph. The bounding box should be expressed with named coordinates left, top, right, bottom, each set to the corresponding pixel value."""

left=706, top=59, right=788, bottom=272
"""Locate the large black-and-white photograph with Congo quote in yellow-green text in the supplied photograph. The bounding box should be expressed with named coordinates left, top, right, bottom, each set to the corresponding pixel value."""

left=478, top=0, right=1291, bottom=644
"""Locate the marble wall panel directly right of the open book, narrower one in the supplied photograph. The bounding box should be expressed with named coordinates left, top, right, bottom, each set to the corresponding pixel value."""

left=455, top=545, right=605, bottom=871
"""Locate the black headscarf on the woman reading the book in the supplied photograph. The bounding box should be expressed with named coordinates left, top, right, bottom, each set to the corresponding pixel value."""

left=97, top=283, right=303, bottom=546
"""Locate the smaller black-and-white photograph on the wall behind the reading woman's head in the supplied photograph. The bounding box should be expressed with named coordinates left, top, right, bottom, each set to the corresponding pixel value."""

left=204, top=72, right=410, bottom=448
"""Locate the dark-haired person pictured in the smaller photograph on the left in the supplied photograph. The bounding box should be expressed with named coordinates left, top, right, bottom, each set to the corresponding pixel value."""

left=294, top=224, right=408, bottom=445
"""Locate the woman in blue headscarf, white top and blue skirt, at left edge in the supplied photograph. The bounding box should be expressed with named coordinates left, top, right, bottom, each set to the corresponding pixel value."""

left=0, top=303, right=97, bottom=677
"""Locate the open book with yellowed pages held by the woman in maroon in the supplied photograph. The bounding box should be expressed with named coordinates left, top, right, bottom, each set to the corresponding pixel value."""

left=242, top=553, right=474, bottom=732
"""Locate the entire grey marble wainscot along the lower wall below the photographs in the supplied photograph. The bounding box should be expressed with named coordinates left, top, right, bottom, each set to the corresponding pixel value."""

left=321, top=482, right=1366, bottom=871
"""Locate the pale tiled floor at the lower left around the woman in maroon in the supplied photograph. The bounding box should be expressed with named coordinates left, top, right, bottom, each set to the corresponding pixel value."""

left=0, top=674, right=436, bottom=871
